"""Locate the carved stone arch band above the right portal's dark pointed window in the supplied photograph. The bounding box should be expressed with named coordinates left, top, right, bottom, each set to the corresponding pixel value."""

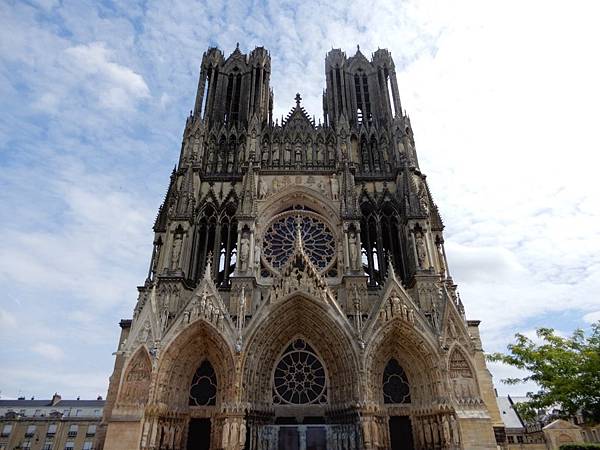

left=364, top=319, right=442, bottom=407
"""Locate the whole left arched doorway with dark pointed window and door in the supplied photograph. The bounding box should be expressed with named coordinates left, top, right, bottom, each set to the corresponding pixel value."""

left=141, top=319, right=235, bottom=450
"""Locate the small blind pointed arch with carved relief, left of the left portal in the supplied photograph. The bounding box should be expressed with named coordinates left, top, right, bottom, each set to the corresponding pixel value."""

left=117, top=345, right=152, bottom=406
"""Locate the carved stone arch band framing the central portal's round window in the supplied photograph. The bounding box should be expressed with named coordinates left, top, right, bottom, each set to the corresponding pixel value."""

left=242, top=295, right=359, bottom=406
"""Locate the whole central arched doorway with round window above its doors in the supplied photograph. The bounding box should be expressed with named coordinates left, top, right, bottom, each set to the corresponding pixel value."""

left=243, top=296, right=360, bottom=450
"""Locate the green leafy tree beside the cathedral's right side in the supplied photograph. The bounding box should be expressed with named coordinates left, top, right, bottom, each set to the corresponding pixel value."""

left=487, top=321, right=600, bottom=422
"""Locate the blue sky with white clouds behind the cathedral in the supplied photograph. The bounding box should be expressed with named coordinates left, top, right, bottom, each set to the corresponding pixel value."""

left=0, top=0, right=600, bottom=398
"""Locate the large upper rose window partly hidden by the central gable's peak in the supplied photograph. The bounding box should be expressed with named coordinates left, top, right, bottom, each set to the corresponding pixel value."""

left=263, top=210, right=335, bottom=272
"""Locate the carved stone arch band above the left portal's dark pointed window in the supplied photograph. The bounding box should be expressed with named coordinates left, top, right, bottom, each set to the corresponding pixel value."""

left=154, top=319, right=235, bottom=411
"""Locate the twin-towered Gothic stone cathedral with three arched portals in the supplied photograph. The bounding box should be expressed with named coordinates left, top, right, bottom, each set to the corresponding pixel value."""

left=98, top=47, right=504, bottom=450
